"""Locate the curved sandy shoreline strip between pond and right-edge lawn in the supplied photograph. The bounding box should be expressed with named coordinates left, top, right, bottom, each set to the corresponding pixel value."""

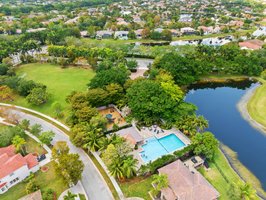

left=237, top=85, right=266, bottom=135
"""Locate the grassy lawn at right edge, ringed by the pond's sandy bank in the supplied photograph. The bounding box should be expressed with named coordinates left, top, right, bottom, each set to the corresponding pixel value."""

left=247, top=79, right=266, bottom=127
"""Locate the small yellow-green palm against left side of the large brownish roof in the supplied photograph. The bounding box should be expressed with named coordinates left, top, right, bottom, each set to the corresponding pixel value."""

left=152, top=174, right=168, bottom=196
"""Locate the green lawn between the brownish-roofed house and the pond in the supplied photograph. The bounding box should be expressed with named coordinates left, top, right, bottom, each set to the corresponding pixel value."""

left=200, top=151, right=241, bottom=200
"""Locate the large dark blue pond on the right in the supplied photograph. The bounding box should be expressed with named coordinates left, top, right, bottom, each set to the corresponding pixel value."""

left=186, top=81, right=266, bottom=190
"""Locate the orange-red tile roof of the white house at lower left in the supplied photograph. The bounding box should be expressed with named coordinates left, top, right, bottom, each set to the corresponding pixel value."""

left=0, top=146, right=38, bottom=179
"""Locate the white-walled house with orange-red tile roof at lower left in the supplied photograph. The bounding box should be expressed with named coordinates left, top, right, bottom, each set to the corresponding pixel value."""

left=0, top=145, right=40, bottom=194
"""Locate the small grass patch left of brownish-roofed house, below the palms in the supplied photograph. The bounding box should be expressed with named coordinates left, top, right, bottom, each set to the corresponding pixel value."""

left=119, top=176, right=152, bottom=200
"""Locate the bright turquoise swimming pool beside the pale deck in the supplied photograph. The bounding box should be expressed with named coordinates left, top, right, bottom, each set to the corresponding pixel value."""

left=140, top=134, right=185, bottom=163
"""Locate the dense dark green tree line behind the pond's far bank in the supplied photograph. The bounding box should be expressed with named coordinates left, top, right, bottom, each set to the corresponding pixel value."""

left=154, top=45, right=266, bottom=85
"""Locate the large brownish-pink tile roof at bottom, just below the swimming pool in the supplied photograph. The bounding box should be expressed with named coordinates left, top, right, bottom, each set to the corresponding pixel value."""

left=158, top=160, right=219, bottom=200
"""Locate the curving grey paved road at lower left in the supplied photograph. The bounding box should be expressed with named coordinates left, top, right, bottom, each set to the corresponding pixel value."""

left=0, top=104, right=113, bottom=200
